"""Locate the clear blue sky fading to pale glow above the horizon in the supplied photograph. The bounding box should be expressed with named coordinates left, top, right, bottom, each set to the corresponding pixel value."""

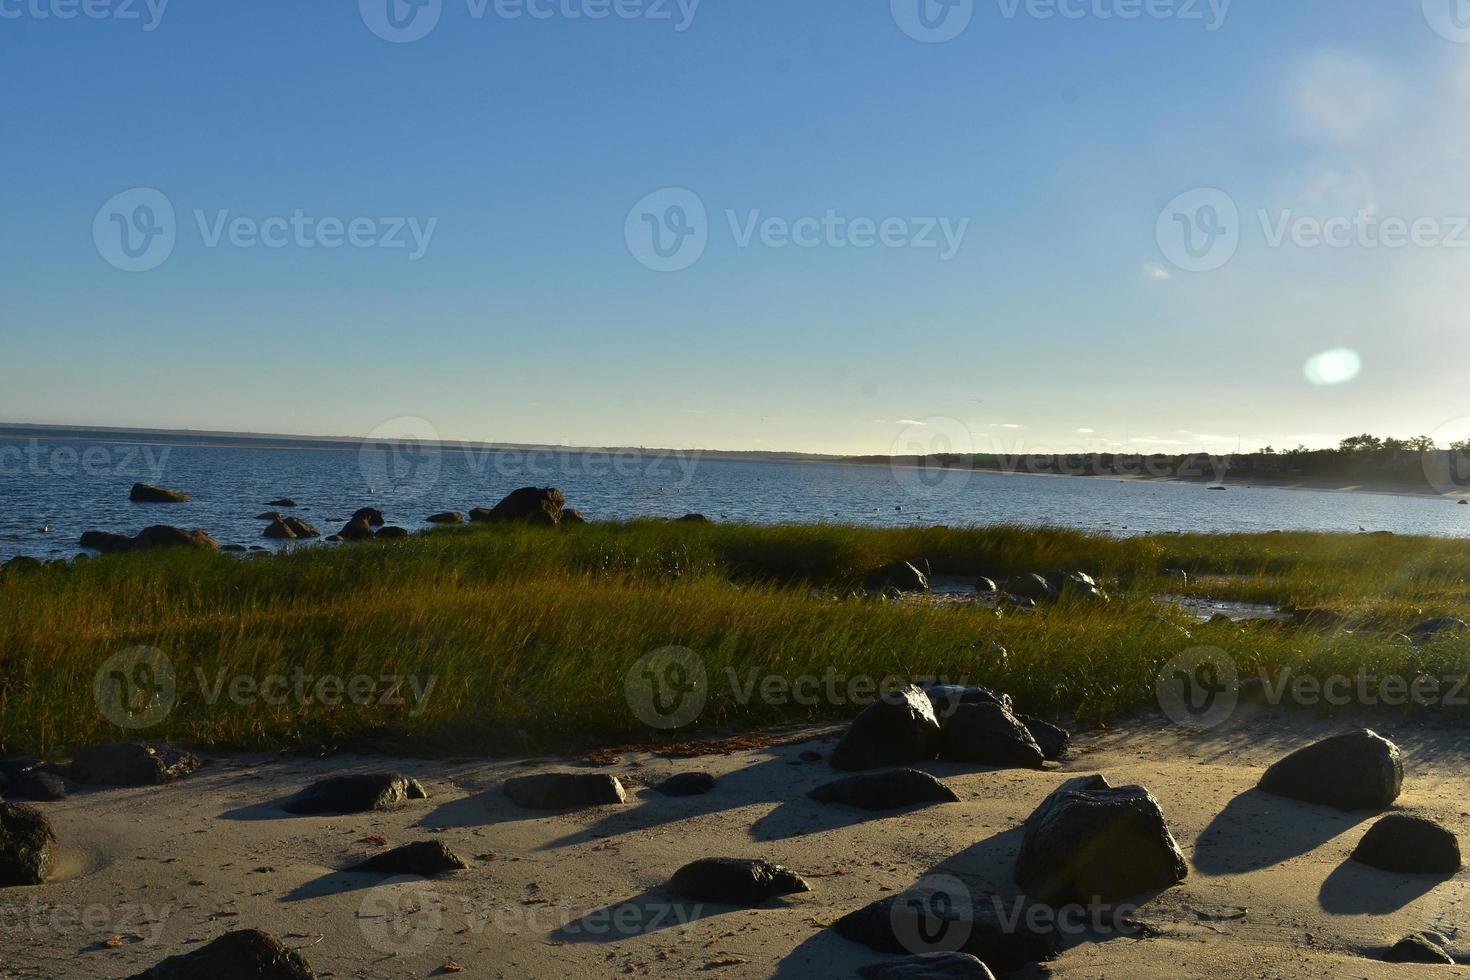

left=0, top=0, right=1470, bottom=453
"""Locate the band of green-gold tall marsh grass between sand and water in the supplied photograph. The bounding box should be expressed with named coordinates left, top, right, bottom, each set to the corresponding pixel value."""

left=0, top=522, right=1470, bottom=754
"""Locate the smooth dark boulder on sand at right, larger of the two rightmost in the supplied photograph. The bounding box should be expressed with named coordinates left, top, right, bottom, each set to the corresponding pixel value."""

left=1260, top=729, right=1404, bottom=810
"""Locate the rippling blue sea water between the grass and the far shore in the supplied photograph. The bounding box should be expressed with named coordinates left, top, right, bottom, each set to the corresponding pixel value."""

left=0, top=438, right=1470, bottom=560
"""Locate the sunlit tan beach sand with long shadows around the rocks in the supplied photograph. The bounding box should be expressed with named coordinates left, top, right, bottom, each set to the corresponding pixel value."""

left=0, top=710, right=1470, bottom=980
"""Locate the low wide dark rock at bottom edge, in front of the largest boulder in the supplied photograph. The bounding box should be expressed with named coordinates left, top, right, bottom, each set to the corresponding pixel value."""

left=832, top=879, right=1061, bottom=971
